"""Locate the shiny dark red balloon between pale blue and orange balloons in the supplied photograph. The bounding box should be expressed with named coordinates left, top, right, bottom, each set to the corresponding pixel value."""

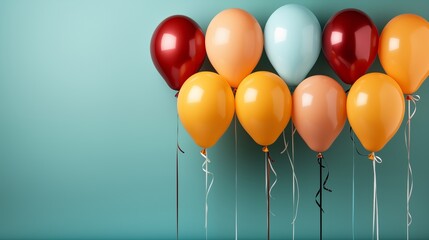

left=322, top=9, right=378, bottom=84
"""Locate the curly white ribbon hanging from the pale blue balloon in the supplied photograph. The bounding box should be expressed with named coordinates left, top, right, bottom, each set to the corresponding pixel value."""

left=281, top=128, right=299, bottom=239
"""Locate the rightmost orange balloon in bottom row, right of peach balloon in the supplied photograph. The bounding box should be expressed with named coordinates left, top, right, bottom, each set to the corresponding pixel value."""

left=347, top=73, right=405, bottom=152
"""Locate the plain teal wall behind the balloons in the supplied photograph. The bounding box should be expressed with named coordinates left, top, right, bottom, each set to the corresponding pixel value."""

left=0, top=0, right=429, bottom=239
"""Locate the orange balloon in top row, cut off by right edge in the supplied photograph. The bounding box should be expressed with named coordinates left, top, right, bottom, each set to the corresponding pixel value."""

left=378, top=14, right=429, bottom=94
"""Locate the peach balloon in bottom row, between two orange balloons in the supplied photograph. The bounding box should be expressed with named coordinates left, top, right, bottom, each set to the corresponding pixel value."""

left=292, top=75, right=347, bottom=153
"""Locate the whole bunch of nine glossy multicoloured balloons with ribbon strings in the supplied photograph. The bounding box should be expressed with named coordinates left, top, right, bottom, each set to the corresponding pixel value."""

left=151, top=4, right=429, bottom=238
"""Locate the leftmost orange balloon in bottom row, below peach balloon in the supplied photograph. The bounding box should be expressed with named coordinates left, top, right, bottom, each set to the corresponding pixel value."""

left=177, top=72, right=234, bottom=149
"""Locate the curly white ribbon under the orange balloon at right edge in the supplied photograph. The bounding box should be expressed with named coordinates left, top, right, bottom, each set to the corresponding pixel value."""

left=404, top=95, right=420, bottom=240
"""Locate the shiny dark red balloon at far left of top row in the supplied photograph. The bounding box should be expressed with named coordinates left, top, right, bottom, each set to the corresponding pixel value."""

left=150, top=15, right=206, bottom=91
